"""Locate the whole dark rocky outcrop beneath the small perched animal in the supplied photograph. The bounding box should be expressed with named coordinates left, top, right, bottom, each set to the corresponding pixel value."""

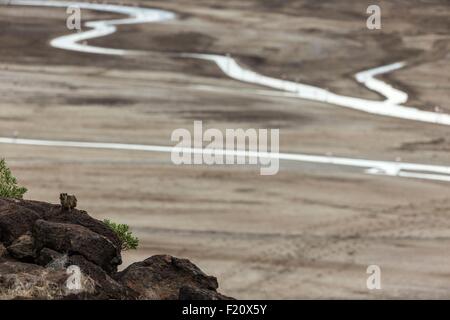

left=0, top=198, right=230, bottom=300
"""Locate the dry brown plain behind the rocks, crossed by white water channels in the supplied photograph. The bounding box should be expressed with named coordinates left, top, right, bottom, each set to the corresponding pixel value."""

left=0, top=0, right=450, bottom=298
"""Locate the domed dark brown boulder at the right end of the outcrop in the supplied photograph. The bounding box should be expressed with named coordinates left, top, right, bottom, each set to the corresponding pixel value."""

left=118, top=255, right=218, bottom=300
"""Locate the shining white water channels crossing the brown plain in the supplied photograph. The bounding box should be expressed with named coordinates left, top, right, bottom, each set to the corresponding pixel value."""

left=0, top=0, right=450, bottom=182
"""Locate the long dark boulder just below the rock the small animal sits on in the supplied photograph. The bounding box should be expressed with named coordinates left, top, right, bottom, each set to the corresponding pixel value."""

left=33, top=220, right=122, bottom=272
